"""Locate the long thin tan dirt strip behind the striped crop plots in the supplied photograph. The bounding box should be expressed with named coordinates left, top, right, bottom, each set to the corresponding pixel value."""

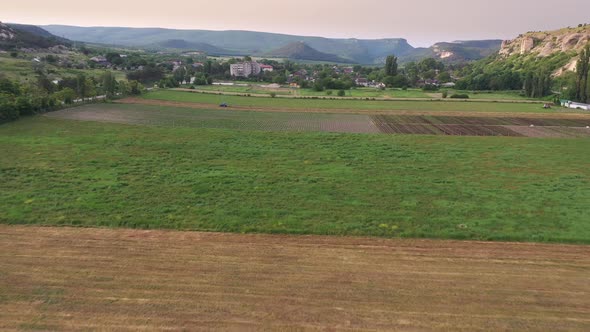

left=116, top=97, right=590, bottom=119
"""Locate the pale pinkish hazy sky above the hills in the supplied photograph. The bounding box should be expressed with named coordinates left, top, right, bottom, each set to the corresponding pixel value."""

left=0, top=0, right=590, bottom=46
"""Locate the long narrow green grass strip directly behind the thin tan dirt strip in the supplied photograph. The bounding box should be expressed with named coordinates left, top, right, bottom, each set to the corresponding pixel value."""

left=143, top=90, right=560, bottom=113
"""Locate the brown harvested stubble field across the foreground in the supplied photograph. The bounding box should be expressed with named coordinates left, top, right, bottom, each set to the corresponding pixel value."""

left=0, top=226, right=590, bottom=331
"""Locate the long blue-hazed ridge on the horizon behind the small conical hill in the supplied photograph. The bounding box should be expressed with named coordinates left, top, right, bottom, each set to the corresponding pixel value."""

left=43, top=25, right=414, bottom=64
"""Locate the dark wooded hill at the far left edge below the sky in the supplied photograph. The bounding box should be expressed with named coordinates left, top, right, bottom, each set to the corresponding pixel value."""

left=0, top=22, right=71, bottom=49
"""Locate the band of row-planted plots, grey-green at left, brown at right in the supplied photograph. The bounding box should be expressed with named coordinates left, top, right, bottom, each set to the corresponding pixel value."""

left=47, top=104, right=590, bottom=137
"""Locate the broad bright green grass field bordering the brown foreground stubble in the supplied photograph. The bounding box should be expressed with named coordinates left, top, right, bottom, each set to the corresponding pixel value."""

left=0, top=115, right=590, bottom=243
